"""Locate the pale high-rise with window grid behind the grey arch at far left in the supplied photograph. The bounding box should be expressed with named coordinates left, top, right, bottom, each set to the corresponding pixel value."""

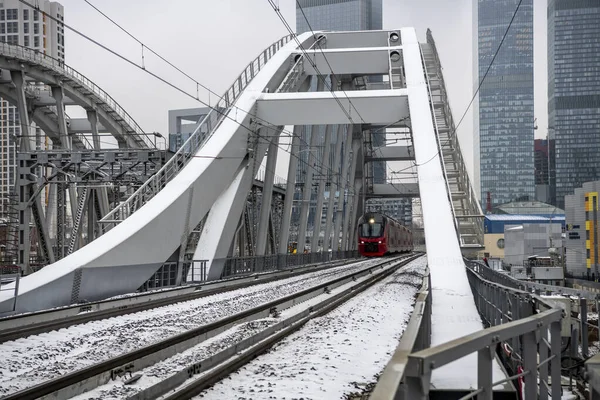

left=0, top=0, right=65, bottom=218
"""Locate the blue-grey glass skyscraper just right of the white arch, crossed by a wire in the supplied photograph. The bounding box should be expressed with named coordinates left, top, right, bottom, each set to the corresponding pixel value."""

left=473, top=0, right=535, bottom=208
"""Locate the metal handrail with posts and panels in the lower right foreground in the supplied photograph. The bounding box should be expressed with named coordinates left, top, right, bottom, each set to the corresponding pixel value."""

left=370, top=260, right=563, bottom=400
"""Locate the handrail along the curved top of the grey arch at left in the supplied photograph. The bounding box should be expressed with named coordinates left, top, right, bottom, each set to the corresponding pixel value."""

left=0, top=42, right=154, bottom=148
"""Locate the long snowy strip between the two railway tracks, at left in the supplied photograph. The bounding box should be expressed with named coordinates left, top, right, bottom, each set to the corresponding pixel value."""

left=0, top=260, right=380, bottom=395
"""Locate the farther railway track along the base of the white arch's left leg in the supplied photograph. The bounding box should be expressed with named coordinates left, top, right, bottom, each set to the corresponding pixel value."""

left=0, top=255, right=360, bottom=344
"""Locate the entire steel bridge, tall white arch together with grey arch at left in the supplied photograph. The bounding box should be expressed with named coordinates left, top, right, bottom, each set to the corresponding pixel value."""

left=0, top=28, right=572, bottom=398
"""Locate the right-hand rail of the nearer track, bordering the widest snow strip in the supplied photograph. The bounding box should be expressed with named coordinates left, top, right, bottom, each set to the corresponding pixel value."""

left=157, top=254, right=421, bottom=400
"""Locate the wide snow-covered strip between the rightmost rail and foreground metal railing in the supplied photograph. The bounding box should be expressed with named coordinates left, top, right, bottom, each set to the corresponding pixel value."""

left=197, top=257, right=427, bottom=400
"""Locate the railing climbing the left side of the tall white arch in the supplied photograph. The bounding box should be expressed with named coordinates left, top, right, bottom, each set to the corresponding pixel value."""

left=100, top=35, right=292, bottom=227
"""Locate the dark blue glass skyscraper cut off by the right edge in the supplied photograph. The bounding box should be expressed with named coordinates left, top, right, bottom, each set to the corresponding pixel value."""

left=548, top=0, right=600, bottom=208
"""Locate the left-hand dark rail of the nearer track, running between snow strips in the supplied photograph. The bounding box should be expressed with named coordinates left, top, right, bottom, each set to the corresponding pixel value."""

left=0, top=257, right=420, bottom=399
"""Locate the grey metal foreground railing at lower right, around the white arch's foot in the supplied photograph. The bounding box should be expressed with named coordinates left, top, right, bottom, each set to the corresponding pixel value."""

left=370, top=262, right=563, bottom=400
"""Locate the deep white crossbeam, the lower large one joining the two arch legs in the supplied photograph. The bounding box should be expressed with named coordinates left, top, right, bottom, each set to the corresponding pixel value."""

left=257, top=89, right=409, bottom=125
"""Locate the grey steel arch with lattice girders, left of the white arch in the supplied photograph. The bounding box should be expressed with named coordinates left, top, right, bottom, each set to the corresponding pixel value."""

left=0, top=43, right=164, bottom=273
